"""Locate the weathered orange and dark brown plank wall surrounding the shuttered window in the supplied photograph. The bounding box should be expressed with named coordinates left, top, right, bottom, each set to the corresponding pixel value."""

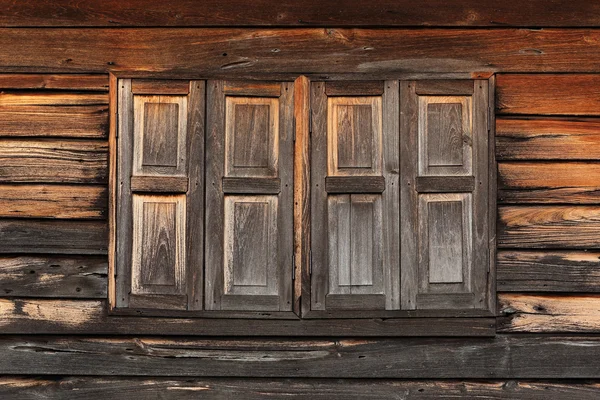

left=0, top=0, right=600, bottom=400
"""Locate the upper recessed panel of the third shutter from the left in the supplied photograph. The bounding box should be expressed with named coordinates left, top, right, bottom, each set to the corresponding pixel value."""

left=327, top=96, right=382, bottom=176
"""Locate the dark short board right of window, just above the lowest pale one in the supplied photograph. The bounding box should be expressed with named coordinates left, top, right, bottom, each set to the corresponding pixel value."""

left=496, top=250, right=600, bottom=292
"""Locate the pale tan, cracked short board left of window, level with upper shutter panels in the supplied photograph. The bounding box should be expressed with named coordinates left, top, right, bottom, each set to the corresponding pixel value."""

left=0, top=139, right=108, bottom=183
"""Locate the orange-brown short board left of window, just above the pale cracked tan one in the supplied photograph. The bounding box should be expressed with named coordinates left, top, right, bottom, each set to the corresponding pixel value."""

left=0, top=105, right=108, bottom=138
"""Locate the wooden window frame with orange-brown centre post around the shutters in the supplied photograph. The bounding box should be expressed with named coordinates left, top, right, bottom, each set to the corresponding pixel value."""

left=108, top=72, right=497, bottom=336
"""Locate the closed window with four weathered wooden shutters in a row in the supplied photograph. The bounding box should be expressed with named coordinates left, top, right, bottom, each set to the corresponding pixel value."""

left=111, top=78, right=495, bottom=318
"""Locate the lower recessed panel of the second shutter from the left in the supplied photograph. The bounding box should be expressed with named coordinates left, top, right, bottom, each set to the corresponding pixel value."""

left=224, top=196, right=277, bottom=294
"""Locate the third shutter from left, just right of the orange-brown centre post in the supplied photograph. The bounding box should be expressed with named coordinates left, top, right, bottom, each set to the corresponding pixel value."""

left=311, top=81, right=400, bottom=311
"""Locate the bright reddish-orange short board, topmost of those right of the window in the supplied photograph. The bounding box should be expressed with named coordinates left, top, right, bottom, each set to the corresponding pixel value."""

left=496, top=75, right=600, bottom=115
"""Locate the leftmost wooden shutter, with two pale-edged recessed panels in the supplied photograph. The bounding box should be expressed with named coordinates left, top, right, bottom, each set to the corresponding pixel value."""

left=116, top=79, right=204, bottom=310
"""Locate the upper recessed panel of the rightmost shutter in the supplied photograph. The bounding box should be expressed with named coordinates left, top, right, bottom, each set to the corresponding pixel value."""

left=418, top=96, right=473, bottom=176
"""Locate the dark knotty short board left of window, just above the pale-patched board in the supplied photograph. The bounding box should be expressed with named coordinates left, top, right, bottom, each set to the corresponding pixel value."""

left=0, top=256, right=108, bottom=296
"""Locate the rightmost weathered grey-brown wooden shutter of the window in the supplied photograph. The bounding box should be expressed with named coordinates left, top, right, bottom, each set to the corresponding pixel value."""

left=400, top=80, right=489, bottom=310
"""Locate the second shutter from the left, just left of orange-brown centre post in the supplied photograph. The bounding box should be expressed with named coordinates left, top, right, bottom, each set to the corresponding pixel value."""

left=205, top=81, right=294, bottom=311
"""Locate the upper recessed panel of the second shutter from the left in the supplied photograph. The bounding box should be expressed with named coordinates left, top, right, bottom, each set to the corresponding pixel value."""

left=225, top=96, right=279, bottom=178
